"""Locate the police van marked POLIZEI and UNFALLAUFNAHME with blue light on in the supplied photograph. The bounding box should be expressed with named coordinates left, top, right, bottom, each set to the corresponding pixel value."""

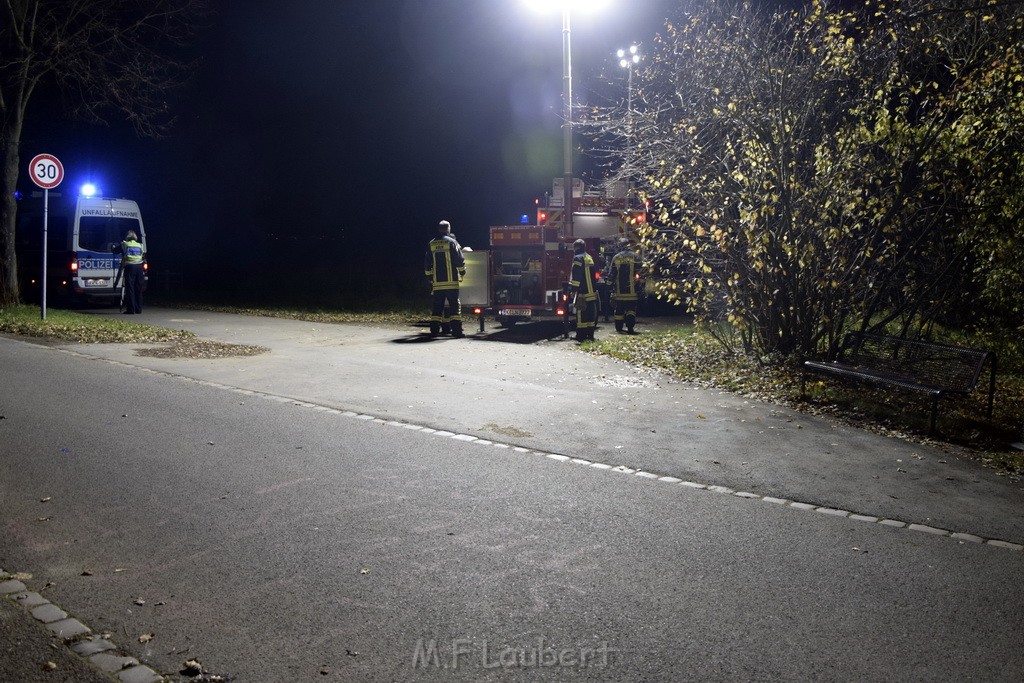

left=15, top=188, right=148, bottom=303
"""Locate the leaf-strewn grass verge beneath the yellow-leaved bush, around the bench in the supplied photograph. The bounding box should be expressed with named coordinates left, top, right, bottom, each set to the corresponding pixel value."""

left=584, top=325, right=1024, bottom=476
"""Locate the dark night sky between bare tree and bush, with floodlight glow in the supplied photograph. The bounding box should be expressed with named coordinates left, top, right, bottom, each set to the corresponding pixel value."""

left=22, top=0, right=685, bottom=296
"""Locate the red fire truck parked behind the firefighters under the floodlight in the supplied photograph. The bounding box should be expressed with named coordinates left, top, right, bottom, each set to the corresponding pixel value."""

left=461, top=178, right=647, bottom=337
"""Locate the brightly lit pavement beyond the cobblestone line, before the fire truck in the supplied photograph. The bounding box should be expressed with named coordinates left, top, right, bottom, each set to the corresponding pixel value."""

left=56, top=308, right=1024, bottom=544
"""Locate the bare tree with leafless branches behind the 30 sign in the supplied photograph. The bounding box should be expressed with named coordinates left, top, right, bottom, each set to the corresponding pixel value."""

left=0, top=0, right=206, bottom=305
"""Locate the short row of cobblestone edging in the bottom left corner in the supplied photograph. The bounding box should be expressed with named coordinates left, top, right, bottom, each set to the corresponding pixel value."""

left=0, top=569, right=167, bottom=683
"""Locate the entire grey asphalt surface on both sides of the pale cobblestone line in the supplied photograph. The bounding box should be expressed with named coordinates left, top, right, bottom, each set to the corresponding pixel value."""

left=0, top=310, right=1024, bottom=681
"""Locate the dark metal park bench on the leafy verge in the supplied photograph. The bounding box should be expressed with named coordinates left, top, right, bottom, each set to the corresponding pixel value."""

left=800, top=332, right=995, bottom=434
